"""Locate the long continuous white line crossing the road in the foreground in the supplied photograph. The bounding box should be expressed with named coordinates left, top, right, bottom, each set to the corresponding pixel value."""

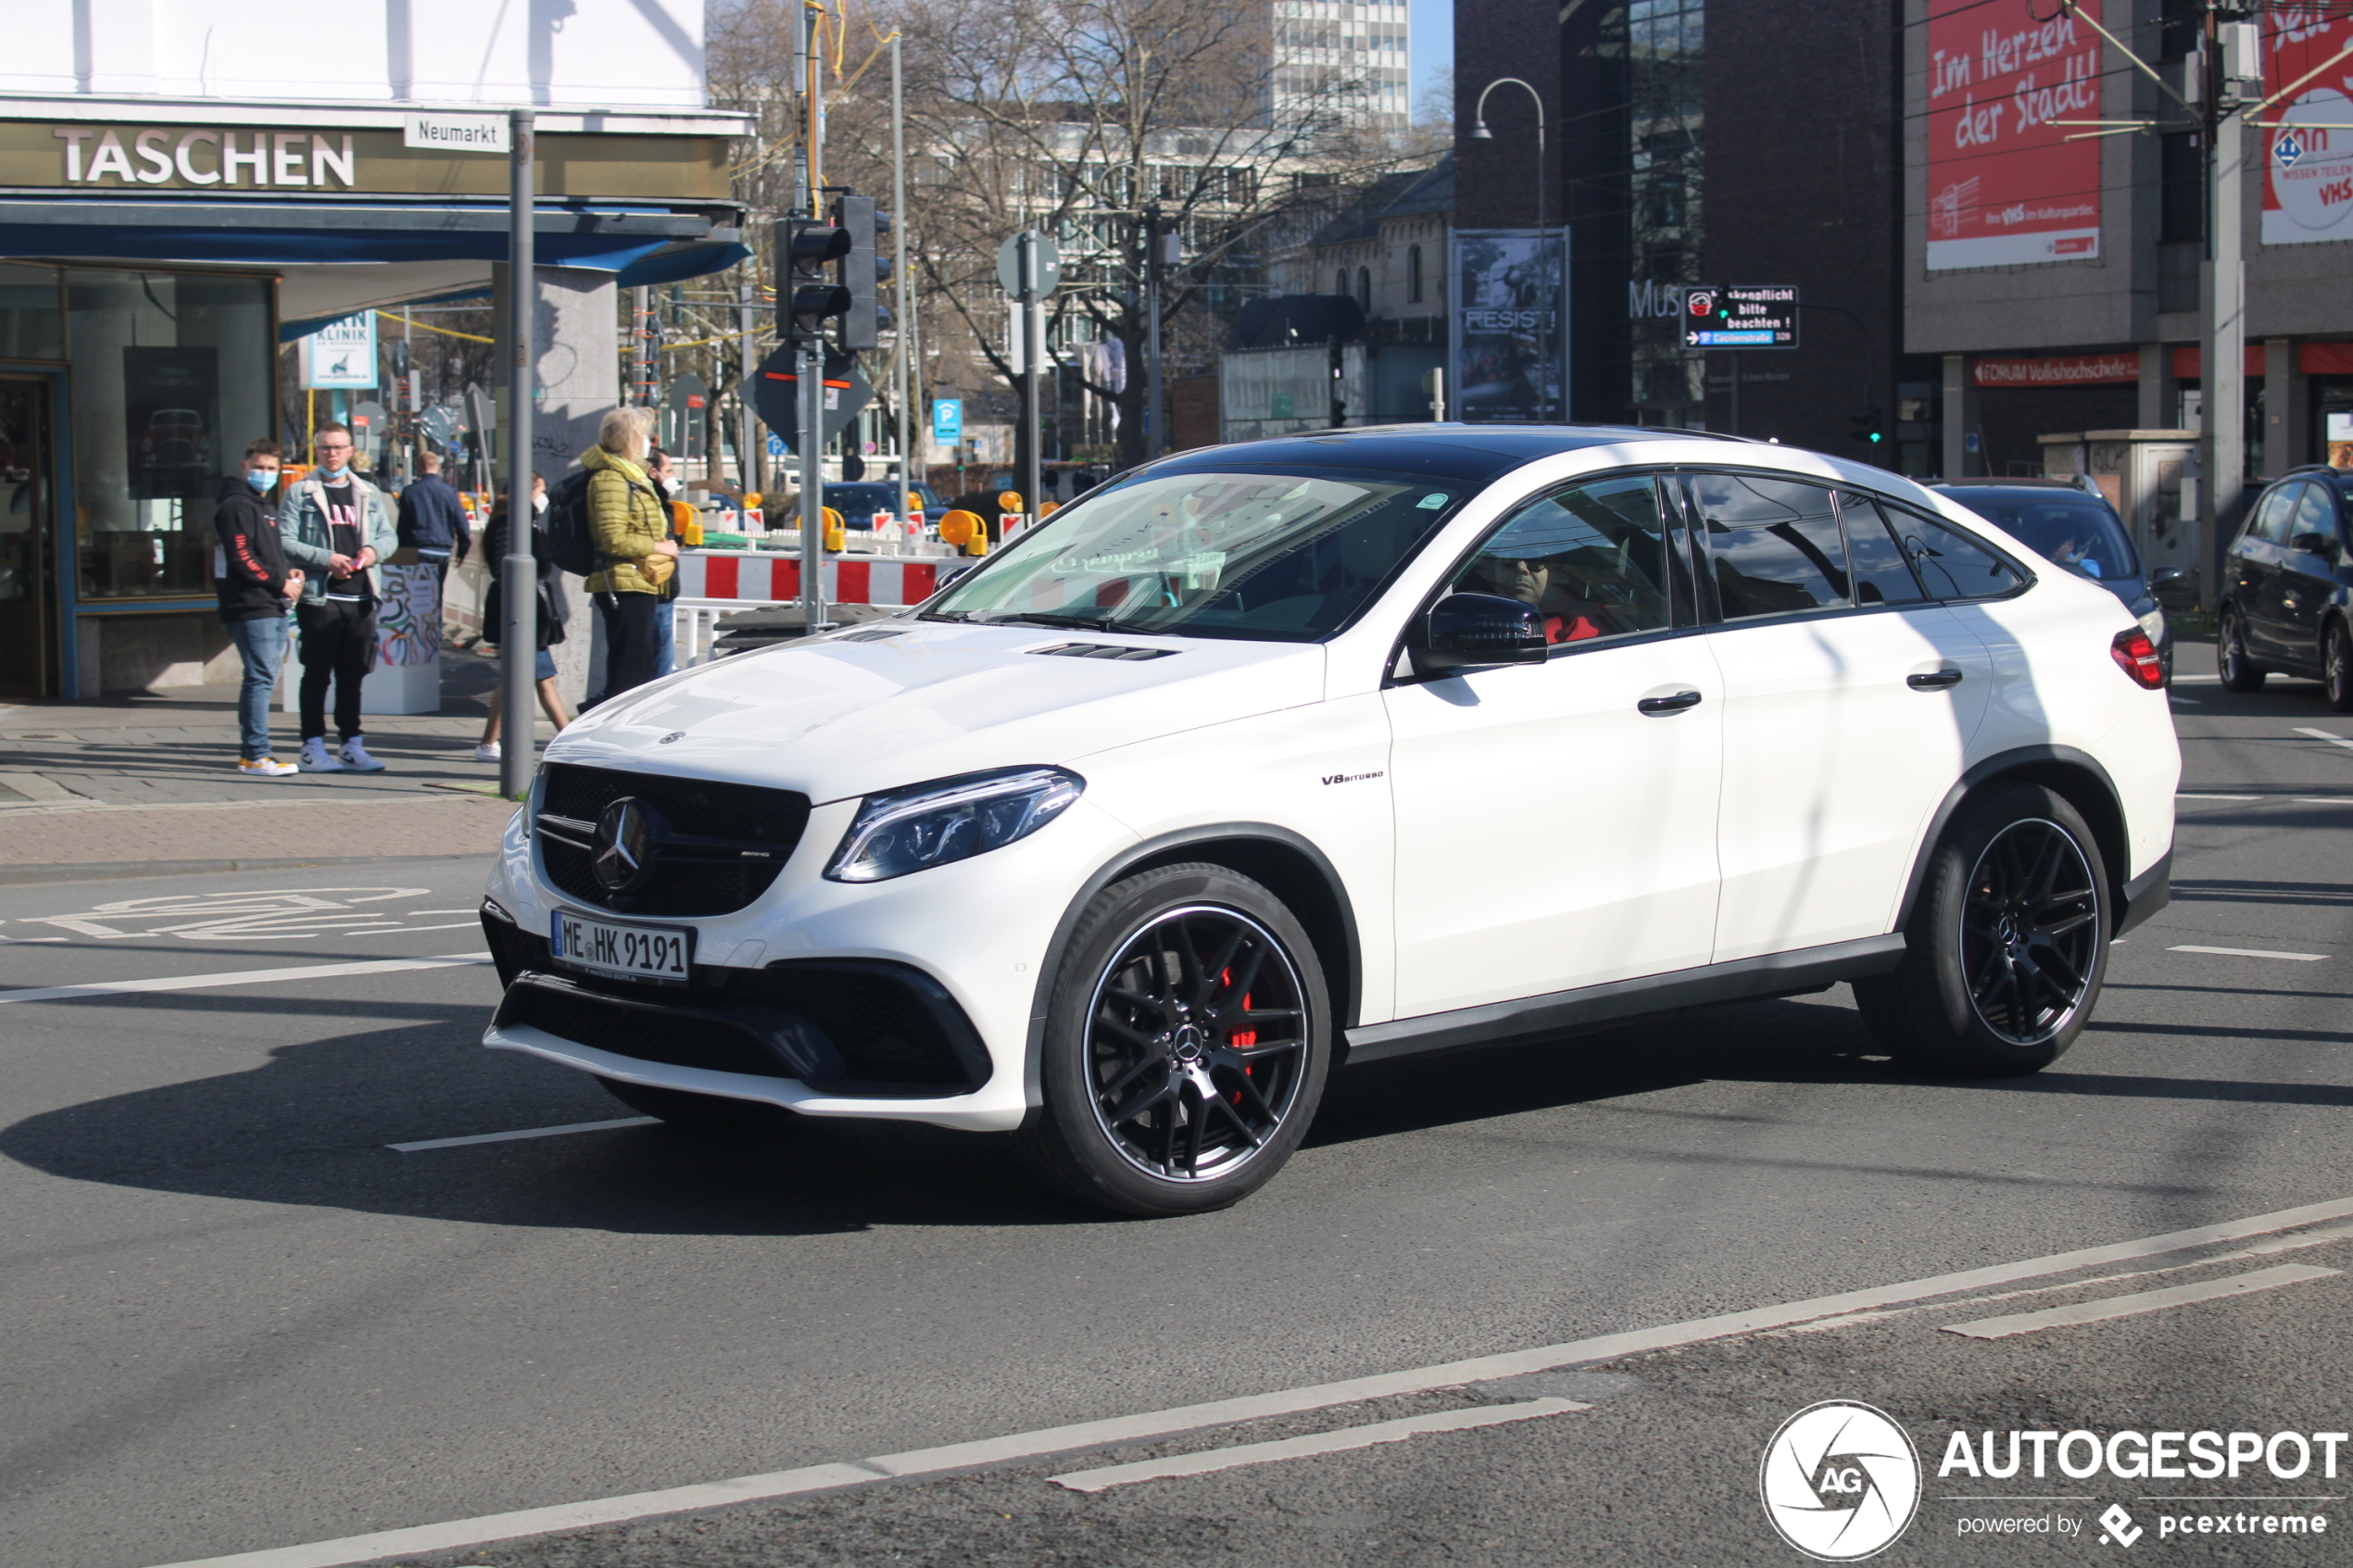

left=133, top=1198, right=2353, bottom=1568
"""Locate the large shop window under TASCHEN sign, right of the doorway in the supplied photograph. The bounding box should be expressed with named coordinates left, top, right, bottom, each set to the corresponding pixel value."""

left=66, top=268, right=275, bottom=599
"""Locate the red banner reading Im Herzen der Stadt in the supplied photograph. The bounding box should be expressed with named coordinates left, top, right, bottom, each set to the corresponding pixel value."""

left=1927, top=0, right=2101, bottom=272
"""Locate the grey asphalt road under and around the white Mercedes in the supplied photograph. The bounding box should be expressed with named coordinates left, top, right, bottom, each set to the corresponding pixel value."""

left=0, top=649, right=2353, bottom=1568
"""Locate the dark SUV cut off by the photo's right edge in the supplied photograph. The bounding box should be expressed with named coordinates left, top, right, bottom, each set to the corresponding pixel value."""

left=2219, top=463, right=2353, bottom=712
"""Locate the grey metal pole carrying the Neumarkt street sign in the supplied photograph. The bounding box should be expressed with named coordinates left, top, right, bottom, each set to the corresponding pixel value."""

left=498, top=108, right=539, bottom=799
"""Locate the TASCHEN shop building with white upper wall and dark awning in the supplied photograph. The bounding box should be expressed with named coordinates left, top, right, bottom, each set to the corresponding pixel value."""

left=0, top=0, right=744, bottom=696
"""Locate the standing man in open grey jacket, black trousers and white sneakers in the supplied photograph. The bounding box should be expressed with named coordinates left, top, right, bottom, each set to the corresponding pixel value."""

left=278, top=423, right=400, bottom=773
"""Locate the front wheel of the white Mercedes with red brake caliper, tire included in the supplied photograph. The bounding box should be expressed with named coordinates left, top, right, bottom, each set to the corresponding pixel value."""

left=1016, top=865, right=1332, bottom=1215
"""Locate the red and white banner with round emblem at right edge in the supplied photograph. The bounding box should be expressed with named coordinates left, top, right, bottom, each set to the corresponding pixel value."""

left=2261, top=3, right=2353, bottom=245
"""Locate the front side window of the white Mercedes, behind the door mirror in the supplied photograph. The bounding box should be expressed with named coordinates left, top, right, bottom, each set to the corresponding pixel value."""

left=1452, top=475, right=1668, bottom=642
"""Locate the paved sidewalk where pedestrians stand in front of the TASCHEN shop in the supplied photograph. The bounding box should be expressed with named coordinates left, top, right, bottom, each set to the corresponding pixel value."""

left=0, top=651, right=553, bottom=882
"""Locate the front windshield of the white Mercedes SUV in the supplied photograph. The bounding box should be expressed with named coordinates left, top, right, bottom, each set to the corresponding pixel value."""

left=925, top=468, right=1478, bottom=642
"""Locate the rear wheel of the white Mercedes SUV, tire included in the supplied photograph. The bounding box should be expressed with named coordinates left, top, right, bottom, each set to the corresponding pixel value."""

left=1855, top=785, right=2113, bottom=1077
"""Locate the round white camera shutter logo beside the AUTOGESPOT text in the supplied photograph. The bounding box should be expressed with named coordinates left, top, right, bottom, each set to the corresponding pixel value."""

left=1757, top=1399, right=1920, bottom=1563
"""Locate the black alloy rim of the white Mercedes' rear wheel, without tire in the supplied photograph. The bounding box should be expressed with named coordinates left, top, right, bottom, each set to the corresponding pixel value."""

left=1960, top=818, right=2101, bottom=1047
